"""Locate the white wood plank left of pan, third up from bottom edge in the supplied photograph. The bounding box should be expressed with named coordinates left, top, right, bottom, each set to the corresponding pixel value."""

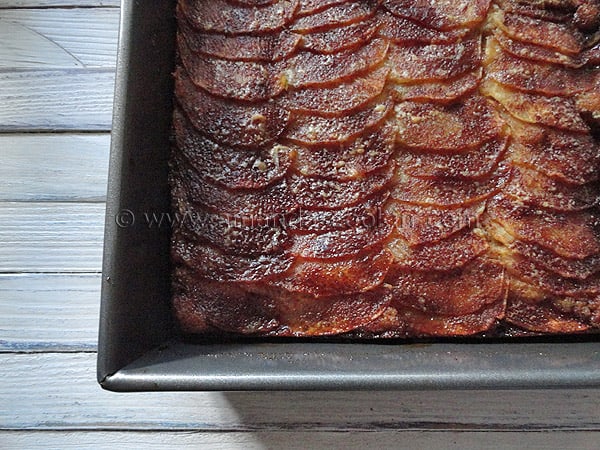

left=0, top=274, right=101, bottom=352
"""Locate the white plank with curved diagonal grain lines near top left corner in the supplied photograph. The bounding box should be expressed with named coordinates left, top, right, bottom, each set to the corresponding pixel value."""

left=0, top=8, right=119, bottom=68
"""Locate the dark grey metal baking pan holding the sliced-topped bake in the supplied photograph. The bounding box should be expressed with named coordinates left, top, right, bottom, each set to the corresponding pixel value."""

left=98, top=0, right=600, bottom=391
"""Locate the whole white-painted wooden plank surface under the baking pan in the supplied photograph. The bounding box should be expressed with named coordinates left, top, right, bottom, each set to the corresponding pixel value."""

left=0, top=0, right=600, bottom=449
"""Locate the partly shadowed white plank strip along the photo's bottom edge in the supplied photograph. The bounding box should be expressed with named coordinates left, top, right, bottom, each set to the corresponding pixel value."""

left=0, top=431, right=600, bottom=450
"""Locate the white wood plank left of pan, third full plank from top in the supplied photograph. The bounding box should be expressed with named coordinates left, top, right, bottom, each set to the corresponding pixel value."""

left=0, top=133, right=110, bottom=201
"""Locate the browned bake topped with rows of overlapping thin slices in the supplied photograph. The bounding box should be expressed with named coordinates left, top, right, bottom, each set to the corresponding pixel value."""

left=170, top=0, right=600, bottom=337
